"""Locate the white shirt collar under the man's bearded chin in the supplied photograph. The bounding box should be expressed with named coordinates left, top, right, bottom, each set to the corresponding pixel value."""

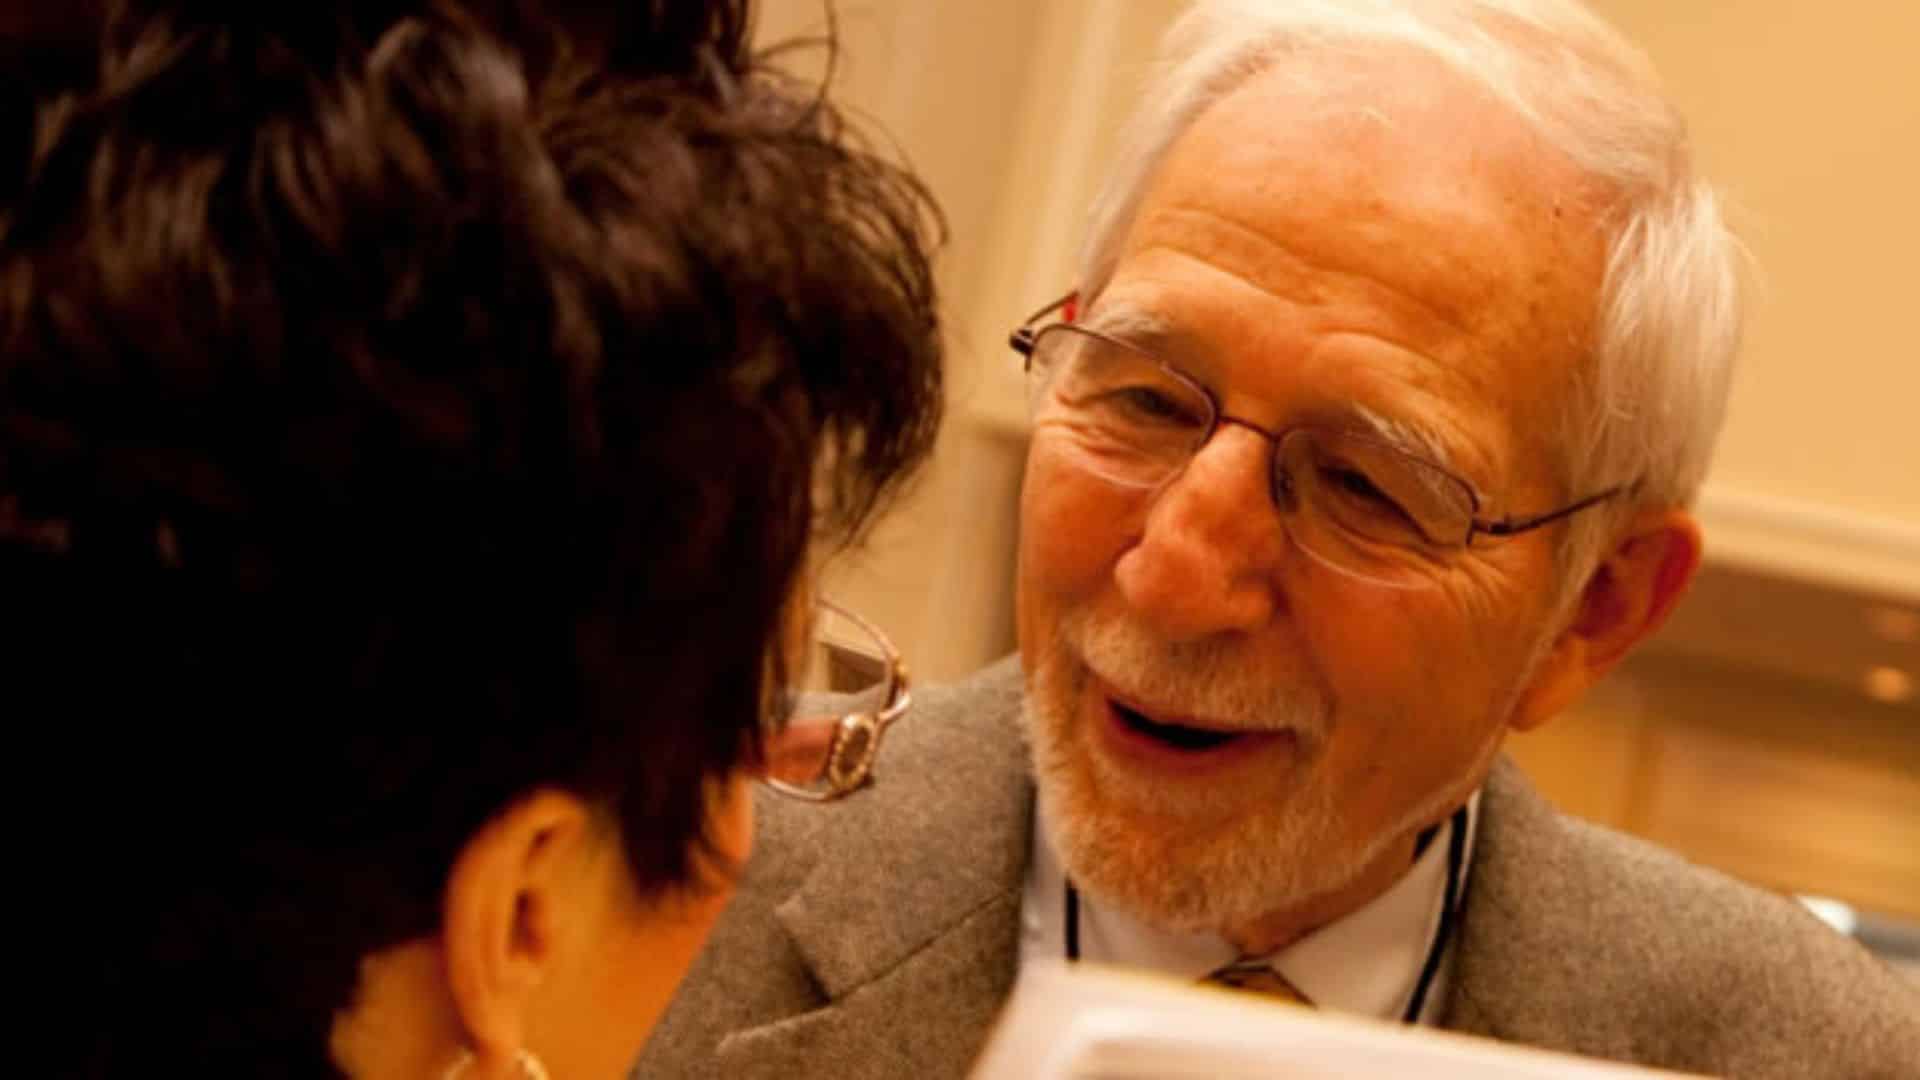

left=1021, top=780, right=1480, bottom=1022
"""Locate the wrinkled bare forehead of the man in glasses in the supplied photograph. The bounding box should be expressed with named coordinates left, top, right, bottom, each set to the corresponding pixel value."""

left=1094, top=52, right=1607, bottom=428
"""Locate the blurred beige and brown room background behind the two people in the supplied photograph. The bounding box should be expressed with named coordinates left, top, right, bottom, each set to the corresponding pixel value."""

left=756, top=0, right=1920, bottom=980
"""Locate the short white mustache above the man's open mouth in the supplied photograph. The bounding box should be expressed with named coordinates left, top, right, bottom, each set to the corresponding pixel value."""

left=1058, top=613, right=1329, bottom=740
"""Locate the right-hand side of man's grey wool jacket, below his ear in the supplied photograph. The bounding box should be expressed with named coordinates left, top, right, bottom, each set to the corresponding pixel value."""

left=1448, top=763, right=1920, bottom=1076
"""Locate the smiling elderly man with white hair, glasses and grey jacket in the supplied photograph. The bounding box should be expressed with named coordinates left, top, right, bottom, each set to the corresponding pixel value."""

left=641, top=0, right=1920, bottom=1078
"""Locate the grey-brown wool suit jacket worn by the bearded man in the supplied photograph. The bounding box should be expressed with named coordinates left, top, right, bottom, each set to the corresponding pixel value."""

left=636, top=661, right=1920, bottom=1080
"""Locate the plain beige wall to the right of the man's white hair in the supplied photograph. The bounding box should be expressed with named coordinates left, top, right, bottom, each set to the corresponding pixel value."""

left=1594, top=0, right=1920, bottom=596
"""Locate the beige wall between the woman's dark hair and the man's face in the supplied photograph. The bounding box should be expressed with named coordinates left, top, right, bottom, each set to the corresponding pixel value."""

left=758, top=0, right=1181, bottom=678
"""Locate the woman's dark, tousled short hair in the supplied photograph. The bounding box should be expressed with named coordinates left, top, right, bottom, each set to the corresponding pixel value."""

left=0, top=0, right=941, bottom=1076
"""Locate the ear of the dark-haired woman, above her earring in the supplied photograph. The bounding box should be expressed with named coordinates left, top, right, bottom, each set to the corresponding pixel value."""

left=442, top=790, right=591, bottom=1076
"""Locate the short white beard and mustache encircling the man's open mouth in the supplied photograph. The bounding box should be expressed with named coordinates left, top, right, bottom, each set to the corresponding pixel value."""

left=1023, top=617, right=1511, bottom=934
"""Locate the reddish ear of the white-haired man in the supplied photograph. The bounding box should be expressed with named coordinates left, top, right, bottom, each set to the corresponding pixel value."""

left=1507, top=509, right=1701, bottom=730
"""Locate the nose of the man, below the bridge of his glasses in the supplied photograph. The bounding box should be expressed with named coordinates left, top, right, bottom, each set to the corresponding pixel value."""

left=1114, top=425, right=1286, bottom=640
